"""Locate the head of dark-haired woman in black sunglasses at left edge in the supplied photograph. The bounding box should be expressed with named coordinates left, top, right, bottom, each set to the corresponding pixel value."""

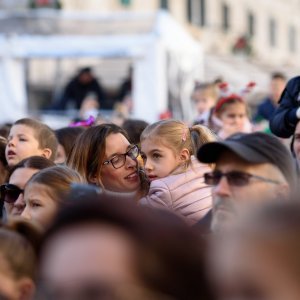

left=0, top=156, right=55, bottom=217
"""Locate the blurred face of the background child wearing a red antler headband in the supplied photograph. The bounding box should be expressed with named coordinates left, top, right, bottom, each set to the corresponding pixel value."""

left=219, top=103, right=248, bottom=131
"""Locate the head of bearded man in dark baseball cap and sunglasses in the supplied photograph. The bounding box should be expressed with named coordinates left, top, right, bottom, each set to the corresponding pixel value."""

left=197, top=132, right=296, bottom=231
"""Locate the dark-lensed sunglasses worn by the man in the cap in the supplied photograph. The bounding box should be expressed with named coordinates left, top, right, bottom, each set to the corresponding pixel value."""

left=204, top=171, right=279, bottom=186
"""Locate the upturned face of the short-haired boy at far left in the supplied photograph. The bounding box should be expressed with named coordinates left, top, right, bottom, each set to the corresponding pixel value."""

left=5, top=124, right=44, bottom=166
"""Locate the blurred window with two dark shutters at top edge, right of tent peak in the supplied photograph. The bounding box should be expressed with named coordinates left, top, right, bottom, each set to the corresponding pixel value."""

left=187, top=0, right=207, bottom=27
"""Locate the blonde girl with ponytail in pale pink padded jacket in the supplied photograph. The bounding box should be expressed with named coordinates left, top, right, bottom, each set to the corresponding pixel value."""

left=140, top=120, right=216, bottom=224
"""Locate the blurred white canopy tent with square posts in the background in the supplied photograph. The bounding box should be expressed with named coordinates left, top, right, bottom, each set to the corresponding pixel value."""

left=0, top=12, right=203, bottom=122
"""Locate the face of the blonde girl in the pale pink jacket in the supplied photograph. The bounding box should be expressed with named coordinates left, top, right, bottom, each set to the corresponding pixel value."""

left=141, top=139, right=182, bottom=181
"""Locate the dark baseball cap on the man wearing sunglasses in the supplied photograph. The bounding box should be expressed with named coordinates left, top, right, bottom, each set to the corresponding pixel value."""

left=197, top=132, right=296, bottom=184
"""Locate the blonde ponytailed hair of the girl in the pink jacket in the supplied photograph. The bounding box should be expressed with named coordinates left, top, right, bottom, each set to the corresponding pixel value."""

left=141, top=119, right=217, bottom=163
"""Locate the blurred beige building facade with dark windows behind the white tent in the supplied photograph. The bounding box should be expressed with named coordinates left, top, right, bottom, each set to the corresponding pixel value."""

left=61, top=0, right=300, bottom=67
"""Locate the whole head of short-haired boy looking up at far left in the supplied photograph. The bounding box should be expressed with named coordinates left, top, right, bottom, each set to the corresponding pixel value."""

left=5, top=118, right=58, bottom=167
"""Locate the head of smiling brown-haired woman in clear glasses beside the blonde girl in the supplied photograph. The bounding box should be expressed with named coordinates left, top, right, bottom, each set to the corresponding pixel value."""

left=67, top=124, right=147, bottom=199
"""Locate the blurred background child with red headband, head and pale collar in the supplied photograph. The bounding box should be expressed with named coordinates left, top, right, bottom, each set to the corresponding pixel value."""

left=214, top=94, right=252, bottom=139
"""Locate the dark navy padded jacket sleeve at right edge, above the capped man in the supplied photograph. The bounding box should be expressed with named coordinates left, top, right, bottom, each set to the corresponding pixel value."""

left=270, top=76, right=300, bottom=138
